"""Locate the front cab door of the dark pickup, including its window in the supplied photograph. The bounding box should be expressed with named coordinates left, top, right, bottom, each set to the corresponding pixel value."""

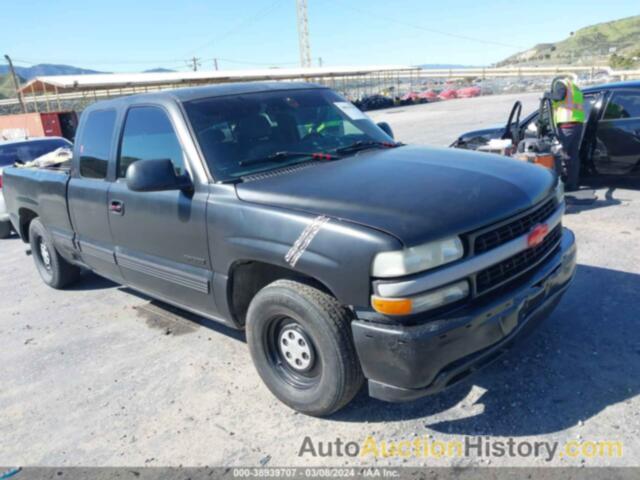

left=108, top=106, right=216, bottom=314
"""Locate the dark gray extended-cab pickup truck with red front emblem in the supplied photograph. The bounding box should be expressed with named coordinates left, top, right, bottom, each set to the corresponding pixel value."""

left=4, top=83, right=576, bottom=415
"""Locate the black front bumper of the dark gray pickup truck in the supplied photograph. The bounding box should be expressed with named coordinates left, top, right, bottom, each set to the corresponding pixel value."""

left=352, top=228, right=576, bottom=401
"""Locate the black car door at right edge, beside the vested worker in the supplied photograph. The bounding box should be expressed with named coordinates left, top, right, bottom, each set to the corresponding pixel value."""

left=593, top=89, right=640, bottom=175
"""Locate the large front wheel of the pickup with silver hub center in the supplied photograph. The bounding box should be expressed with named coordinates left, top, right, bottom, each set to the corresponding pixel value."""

left=246, top=280, right=364, bottom=416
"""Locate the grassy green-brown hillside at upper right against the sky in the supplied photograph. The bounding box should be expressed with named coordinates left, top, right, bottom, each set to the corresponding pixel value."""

left=498, top=15, right=640, bottom=68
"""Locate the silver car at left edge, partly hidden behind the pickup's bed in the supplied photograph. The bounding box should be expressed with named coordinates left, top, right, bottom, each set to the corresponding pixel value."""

left=0, top=137, right=71, bottom=238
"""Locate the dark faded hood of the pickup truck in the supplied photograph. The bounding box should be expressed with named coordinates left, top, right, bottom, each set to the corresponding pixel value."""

left=236, top=146, right=555, bottom=246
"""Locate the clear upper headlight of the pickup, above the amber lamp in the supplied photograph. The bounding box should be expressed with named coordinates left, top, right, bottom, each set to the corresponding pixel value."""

left=372, top=237, right=464, bottom=278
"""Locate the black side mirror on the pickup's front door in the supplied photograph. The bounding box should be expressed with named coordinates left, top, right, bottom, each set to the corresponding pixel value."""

left=126, top=158, right=193, bottom=192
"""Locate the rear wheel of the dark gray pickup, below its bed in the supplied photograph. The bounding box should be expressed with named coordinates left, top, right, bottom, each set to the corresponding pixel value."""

left=29, top=218, right=80, bottom=289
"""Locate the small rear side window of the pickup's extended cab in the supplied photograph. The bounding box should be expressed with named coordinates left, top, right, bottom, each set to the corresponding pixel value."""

left=78, top=110, right=116, bottom=179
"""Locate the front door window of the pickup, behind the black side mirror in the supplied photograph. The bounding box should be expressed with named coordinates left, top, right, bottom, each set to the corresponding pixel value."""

left=118, top=107, right=185, bottom=177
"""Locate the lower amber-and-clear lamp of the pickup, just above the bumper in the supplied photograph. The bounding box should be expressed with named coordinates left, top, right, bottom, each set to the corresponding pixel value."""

left=371, top=280, right=469, bottom=315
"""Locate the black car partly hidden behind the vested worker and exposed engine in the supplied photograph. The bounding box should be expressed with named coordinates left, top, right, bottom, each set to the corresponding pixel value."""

left=452, top=81, right=640, bottom=180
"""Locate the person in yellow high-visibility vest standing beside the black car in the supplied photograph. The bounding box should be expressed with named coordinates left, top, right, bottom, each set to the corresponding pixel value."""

left=550, top=78, right=585, bottom=190
